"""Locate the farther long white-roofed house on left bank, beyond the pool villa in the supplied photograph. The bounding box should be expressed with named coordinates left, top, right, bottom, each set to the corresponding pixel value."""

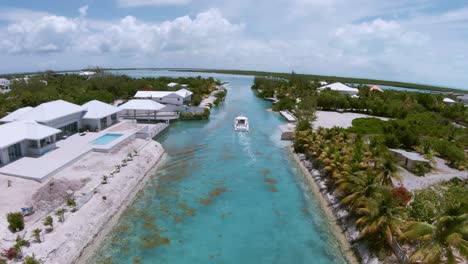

left=134, top=88, right=193, bottom=105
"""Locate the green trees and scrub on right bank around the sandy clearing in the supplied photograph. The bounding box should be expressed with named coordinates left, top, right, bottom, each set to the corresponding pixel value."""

left=252, top=72, right=468, bottom=169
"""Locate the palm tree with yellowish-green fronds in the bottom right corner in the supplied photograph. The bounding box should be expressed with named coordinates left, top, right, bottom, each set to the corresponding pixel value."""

left=402, top=213, right=468, bottom=263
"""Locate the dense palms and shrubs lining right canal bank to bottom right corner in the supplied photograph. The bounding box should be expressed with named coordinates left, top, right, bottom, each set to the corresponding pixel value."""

left=294, top=127, right=468, bottom=263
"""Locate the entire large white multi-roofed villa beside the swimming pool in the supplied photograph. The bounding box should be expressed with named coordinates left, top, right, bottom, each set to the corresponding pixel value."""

left=0, top=100, right=120, bottom=165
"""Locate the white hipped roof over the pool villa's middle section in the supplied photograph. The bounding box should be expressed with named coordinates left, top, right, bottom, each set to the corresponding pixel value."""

left=5, top=100, right=86, bottom=122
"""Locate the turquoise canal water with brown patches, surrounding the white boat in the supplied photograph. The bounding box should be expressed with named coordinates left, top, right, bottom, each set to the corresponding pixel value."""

left=91, top=71, right=345, bottom=264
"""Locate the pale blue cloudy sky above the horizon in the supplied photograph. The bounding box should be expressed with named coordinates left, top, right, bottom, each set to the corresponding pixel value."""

left=0, top=0, right=468, bottom=89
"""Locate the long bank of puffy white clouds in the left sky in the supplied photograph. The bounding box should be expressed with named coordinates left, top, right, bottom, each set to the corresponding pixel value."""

left=0, top=9, right=243, bottom=57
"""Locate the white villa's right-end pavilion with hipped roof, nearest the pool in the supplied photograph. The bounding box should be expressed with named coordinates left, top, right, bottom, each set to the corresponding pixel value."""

left=82, top=100, right=121, bottom=130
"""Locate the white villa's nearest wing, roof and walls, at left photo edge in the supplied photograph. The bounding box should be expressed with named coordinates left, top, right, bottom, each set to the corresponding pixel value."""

left=0, top=120, right=61, bottom=166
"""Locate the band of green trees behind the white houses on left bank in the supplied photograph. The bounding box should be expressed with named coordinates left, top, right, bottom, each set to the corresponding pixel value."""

left=0, top=72, right=219, bottom=117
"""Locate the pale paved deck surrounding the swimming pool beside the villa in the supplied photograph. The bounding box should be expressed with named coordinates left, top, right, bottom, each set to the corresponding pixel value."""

left=0, top=121, right=167, bottom=182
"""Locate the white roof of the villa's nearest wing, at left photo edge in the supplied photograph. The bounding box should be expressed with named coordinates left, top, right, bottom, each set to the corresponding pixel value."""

left=0, top=121, right=61, bottom=148
